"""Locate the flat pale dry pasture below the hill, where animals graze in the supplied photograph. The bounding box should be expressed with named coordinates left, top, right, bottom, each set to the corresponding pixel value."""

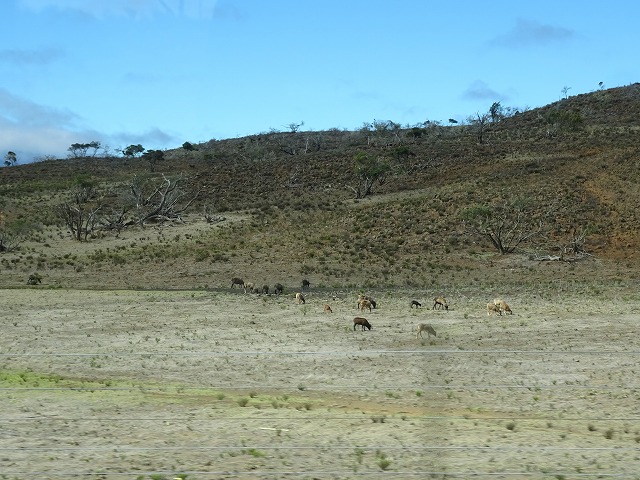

left=0, top=289, right=640, bottom=480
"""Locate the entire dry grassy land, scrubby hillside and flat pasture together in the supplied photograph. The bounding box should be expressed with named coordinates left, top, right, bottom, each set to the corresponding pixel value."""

left=0, top=84, right=640, bottom=480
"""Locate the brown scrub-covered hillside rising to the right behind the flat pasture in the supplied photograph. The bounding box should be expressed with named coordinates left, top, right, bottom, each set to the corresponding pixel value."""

left=0, top=84, right=640, bottom=294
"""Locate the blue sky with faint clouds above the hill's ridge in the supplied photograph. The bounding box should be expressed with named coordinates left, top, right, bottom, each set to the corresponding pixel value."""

left=0, top=0, right=640, bottom=163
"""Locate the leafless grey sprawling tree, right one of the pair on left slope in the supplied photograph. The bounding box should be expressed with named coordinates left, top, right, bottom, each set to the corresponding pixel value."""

left=129, top=174, right=200, bottom=226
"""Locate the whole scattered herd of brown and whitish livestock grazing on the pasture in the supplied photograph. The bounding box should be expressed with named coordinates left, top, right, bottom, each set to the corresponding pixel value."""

left=231, top=277, right=513, bottom=339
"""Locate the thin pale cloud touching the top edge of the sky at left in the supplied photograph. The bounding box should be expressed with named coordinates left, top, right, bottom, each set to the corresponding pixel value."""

left=19, top=0, right=222, bottom=19
